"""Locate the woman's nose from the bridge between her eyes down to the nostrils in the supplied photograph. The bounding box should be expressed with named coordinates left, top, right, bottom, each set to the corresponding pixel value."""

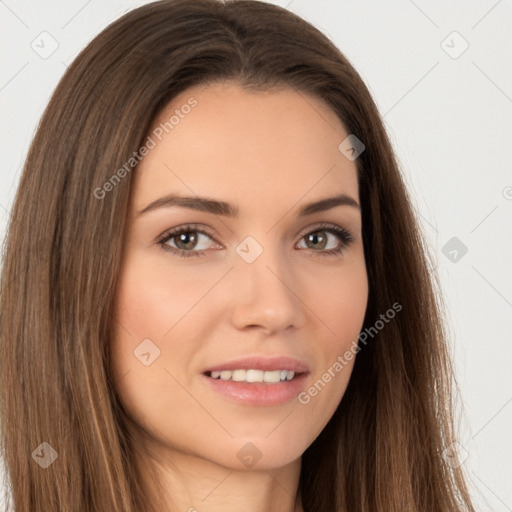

left=233, top=237, right=304, bottom=331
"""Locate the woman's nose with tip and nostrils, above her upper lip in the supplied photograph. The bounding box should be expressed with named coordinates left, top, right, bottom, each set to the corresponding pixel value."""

left=231, top=248, right=307, bottom=334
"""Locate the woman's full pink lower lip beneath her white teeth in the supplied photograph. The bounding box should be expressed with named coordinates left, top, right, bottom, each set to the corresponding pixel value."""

left=203, top=373, right=308, bottom=407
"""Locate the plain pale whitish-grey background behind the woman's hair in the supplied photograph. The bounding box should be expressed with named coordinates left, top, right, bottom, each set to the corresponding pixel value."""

left=0, top=0, right=512, bottom=512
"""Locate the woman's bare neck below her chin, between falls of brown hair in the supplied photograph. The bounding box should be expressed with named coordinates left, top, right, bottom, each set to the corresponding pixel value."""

left=137, top=442, right=303, bottom=512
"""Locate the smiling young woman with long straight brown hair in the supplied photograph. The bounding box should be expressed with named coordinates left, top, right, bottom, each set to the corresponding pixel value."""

left=0, top=0, right=474, bottom=512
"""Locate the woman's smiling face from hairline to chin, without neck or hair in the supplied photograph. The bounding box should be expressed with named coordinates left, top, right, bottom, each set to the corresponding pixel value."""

left=113, top=85, right=368, bottom=469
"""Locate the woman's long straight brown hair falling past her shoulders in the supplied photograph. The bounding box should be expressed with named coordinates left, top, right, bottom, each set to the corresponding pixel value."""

left=0, top=0, right=474, bottom=512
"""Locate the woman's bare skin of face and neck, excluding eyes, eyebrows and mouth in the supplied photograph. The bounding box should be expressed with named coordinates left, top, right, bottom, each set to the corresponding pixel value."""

left=112, top=83, right=368, bottom=512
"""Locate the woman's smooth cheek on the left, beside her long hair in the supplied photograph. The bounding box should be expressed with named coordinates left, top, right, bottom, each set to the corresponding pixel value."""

left=112, top=254, right=222, bottom=392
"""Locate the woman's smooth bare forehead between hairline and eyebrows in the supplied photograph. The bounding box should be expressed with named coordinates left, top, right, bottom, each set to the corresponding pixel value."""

left=133, top=84, right=358, bottom=216
